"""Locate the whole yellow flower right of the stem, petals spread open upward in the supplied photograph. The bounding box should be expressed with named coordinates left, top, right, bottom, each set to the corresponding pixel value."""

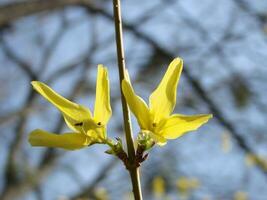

left=122, top=58, right=212, bottom=145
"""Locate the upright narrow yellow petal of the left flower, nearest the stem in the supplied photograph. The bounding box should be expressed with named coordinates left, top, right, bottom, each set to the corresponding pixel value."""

left=94, top=65, right=112, bottom=125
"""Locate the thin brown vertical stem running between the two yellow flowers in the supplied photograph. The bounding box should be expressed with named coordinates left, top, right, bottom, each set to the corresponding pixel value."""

left=113, top=0, right=142, bottom=200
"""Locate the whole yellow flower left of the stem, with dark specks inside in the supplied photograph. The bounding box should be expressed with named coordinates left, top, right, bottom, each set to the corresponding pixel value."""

left=29, top=65, right=112, bottom=150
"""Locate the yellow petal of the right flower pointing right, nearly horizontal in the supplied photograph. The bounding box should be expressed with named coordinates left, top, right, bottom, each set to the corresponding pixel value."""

left=161, top=114, right=212, bottom=139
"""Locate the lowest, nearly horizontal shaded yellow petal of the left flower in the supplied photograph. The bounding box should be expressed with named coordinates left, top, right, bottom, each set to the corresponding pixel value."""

left=28, top=129, right=90, bottom=150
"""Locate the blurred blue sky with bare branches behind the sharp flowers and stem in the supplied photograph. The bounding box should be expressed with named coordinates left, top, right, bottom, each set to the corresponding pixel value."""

left=0, top=0, right=267, bottom=200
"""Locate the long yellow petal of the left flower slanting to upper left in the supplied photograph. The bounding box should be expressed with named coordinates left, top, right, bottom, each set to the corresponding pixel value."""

left=31, top=81, right=92, bottom=130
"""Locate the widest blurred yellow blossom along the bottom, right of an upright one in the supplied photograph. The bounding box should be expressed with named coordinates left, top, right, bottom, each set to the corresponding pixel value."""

left=176, top=177, right=200, bottom=200
